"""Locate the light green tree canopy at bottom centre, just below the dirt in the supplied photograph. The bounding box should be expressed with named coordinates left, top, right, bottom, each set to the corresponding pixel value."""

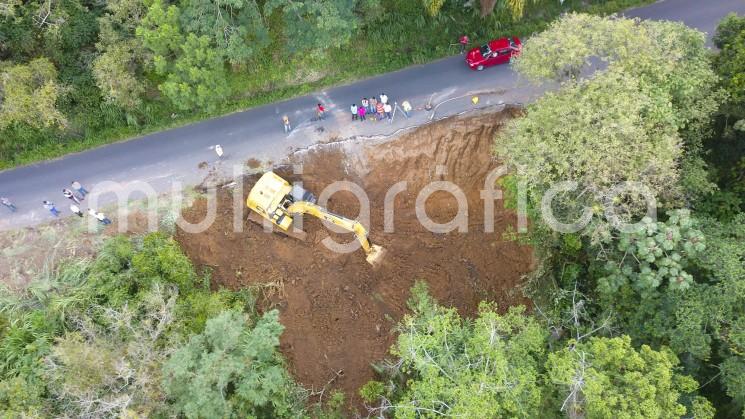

left=368, top=283, right=545, bottom=418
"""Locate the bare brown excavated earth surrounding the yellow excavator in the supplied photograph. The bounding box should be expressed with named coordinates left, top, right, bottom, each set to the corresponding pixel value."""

left=177, top=109, right=532, bottom=412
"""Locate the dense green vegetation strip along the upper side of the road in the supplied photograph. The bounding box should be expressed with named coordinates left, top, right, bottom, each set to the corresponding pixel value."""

left=0, top=0, right=646, bottom=168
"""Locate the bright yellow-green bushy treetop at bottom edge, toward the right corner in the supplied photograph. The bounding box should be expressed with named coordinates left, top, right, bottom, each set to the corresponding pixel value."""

left=546, top=336, right=713, bottom=419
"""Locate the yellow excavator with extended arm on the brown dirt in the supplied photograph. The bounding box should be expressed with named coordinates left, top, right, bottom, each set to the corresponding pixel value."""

left=246, top=171, right=385, bottom=266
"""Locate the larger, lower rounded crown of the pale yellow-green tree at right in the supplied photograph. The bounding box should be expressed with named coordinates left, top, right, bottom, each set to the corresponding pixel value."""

left=495, top=70, right=682, bottom=213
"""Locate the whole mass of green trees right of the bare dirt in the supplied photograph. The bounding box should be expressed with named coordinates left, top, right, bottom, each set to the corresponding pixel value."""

left=361, top=11, right=745, bottom=418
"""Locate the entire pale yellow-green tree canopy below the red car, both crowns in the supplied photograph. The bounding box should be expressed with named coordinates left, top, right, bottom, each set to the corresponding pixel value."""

left=495, top=14, right=722, bottom=239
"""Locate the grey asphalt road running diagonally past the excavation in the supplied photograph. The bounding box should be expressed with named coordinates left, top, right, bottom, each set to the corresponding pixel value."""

left=0, top=0, right=745, bottom=230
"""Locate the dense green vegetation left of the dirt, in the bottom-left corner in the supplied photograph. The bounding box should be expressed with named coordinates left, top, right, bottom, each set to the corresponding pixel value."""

left=0, top=233, right=305, bottom=418
